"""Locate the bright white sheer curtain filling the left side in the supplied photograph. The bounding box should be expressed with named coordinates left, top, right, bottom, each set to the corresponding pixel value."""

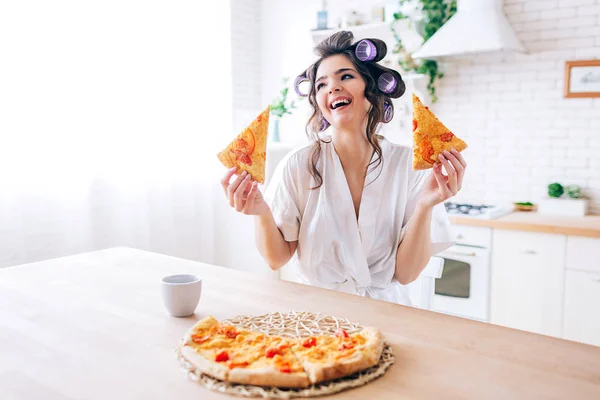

left=0, top=0, right=232, bottom=267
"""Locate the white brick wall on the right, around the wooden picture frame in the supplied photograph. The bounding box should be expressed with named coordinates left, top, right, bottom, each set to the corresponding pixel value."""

left=433, top=0, right=600, bottom=214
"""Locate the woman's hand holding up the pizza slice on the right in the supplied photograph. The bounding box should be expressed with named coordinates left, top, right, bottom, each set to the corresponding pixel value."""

left=419, top=149, right=467, bottom=207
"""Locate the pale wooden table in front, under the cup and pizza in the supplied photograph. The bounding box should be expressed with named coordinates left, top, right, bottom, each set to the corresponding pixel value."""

left=0, top=248, right=600, bottom=400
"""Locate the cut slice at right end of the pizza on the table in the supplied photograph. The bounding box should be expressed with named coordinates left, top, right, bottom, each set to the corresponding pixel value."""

left=292, top=328, right=383, bottom=384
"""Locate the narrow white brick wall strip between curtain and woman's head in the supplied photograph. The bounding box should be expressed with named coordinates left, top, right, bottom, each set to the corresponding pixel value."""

left=231, top=0, right=262, bottom=132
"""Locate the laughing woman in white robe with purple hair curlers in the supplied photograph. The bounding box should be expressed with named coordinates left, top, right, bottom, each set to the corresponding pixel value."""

left=221, top=31, right=466, bottom=304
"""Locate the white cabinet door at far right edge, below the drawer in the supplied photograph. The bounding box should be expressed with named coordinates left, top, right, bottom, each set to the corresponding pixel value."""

left=563, top=270, right=600, bottom=346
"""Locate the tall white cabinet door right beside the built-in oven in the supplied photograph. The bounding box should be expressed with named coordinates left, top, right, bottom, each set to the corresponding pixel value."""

left=490, top=229, right=566, bottom=337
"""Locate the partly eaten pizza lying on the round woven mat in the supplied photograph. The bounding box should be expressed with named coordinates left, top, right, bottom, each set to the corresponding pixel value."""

left=180, top=316, right=384, bottom=388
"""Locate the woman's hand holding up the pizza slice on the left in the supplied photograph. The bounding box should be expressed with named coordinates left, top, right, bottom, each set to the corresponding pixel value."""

left=221, top=167, right=270, bottom=215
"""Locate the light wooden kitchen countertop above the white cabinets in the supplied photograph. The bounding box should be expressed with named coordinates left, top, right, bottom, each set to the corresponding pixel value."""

left=450, top=211, right=600, bottom=238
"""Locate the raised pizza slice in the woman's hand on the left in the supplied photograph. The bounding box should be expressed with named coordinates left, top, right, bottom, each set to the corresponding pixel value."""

left=217, top=107, right=270, bottom=183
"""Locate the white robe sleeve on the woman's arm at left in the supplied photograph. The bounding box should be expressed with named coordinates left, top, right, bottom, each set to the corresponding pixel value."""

left=264, top=157, right=301, bottom=242
